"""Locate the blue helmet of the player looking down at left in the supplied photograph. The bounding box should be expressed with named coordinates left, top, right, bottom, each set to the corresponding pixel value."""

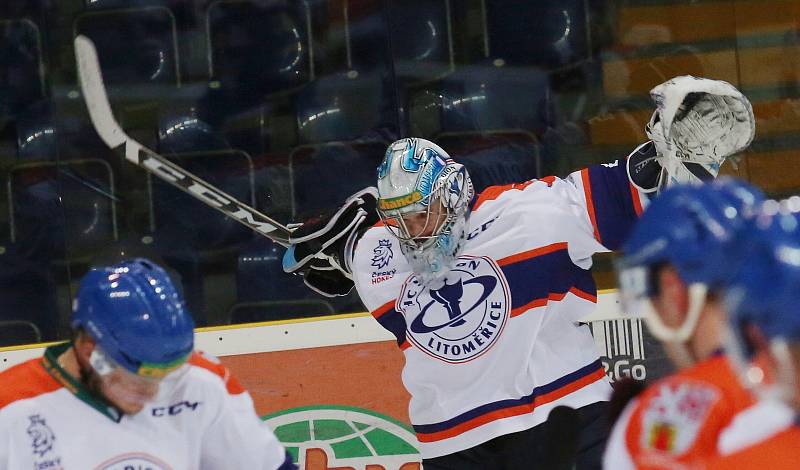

left=72, top=258, right=194, bottom=378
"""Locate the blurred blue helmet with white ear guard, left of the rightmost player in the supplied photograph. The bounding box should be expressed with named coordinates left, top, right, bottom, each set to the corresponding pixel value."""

left=617, top=178, right=764, bottom=342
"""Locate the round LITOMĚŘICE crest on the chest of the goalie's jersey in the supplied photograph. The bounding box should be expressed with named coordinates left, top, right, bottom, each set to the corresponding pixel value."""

left=398, top=255, right=511, bottom=363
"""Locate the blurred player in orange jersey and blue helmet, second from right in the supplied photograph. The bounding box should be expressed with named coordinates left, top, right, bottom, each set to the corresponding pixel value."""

left=604, top=178, right=764, bottom=468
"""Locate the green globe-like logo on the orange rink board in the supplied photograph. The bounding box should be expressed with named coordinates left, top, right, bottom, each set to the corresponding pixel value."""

left=263, top=406, right=422, bottom=470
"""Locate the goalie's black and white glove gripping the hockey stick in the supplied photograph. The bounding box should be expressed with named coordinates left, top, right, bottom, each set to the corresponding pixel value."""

left=283, top=187, right=379, bottom=297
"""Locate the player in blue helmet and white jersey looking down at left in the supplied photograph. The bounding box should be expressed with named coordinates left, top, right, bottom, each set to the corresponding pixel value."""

left=0, top=259, right=296, bottom=470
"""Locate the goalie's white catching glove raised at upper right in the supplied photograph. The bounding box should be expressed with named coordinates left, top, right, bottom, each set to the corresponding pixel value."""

left=629, top=75, right=755, bottom=192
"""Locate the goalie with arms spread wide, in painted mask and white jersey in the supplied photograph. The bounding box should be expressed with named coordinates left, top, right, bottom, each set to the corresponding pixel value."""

left=283, top=77, right=754, bottom=470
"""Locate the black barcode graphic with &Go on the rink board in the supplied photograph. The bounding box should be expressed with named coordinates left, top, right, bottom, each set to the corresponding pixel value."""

left=589, top=318, right=647, bottom=381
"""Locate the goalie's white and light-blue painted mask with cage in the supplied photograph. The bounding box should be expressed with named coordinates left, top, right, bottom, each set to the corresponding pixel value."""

left=378, top=138, right=475, bottom=283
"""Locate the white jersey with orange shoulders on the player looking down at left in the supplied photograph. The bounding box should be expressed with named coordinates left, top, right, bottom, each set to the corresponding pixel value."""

left=0, top=344, right=296, bottom=470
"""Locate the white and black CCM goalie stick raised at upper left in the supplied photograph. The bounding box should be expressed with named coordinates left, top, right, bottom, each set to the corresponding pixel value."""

left=75, top=35, right=291, bottom=246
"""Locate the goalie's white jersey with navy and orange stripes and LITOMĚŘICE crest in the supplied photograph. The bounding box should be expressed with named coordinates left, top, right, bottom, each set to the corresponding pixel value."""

left=353, top=161, right=645, bottom=458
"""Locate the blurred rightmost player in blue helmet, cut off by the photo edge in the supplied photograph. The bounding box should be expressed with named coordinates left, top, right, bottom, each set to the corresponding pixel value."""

left=704, top=202, right=800, bottom=470
